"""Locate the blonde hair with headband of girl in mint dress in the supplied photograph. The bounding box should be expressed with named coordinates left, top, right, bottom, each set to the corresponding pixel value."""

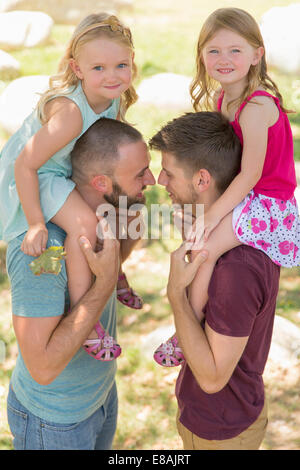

left=37, top=13, right=138, bottom=122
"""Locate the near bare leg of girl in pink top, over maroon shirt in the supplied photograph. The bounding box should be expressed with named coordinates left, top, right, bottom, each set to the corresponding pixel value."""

left=188, top=213, right=241, bottom=321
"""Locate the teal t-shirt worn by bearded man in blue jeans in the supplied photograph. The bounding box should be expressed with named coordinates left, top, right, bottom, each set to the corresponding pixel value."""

left=6, top=223, right=116, bottom=424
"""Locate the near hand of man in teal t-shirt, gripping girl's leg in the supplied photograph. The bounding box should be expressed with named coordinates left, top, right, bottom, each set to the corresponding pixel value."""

left=79, top=217, right=120, bottom=284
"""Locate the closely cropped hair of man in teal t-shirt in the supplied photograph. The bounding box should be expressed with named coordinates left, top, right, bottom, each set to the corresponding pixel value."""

left=71, top=118, right=143, bottom=183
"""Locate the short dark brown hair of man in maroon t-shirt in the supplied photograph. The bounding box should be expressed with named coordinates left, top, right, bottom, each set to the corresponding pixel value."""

left=149, top=111, right=242, bottom=193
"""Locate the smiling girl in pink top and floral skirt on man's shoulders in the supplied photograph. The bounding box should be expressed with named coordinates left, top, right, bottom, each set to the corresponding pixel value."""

left=154, top=8, right=300, bottom=366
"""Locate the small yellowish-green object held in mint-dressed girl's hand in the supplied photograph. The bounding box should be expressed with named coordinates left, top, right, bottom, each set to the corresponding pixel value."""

left=29, top=246, right=66, bottom=276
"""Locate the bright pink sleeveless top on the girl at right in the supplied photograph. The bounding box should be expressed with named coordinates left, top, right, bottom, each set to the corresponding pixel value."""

left=217, top=90, right=297, bottom=200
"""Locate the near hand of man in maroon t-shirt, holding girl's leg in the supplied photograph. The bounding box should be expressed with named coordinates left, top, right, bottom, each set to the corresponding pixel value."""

left=167, top=242, right=208, bottom=296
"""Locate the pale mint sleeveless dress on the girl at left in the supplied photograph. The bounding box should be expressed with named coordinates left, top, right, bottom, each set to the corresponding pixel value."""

left=0, top=82, right=120, bottom=242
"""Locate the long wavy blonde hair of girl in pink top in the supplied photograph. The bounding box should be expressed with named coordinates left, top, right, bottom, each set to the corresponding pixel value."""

left=190, top=8, right=288, bottom=112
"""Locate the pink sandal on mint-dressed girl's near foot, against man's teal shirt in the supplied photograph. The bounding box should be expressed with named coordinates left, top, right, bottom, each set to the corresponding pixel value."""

left=83, top=321, right=122, bottom=362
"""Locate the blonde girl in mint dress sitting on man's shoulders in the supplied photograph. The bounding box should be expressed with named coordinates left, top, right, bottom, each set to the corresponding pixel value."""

left=0, top=13, right=142, bottom=360
